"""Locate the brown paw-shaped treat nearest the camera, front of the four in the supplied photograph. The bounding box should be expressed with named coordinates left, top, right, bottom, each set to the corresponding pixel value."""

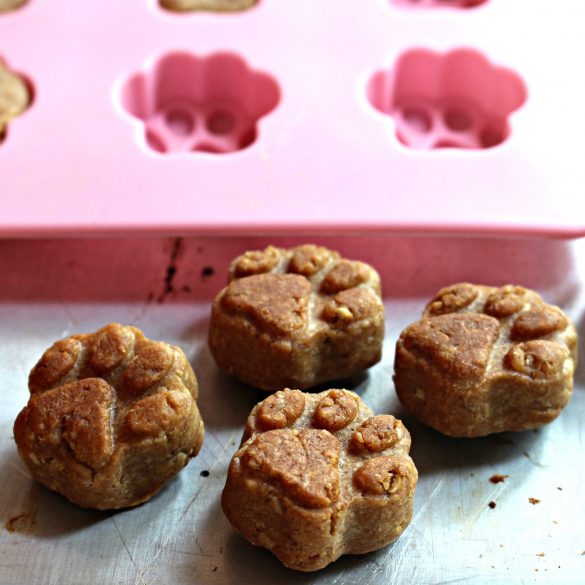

left=222, top=389, right=418, bottom=571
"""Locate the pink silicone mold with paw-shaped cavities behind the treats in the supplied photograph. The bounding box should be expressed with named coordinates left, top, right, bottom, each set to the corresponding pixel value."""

left=0, top=0, right=585, bottom=237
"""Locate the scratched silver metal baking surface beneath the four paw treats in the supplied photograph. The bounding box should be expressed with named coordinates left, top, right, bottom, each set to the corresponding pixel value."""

left=0, top=238, right=585, bottom=585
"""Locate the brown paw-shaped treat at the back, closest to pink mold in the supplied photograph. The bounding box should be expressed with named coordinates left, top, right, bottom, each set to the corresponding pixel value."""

left=209, top=245, right=384, bottom=391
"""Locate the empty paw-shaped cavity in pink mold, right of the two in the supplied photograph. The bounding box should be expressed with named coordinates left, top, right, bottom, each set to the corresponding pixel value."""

left=367, top=49, right=527, bottom=150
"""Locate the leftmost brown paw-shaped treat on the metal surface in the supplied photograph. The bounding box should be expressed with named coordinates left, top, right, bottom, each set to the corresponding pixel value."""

left=14, top=323, right=203, bottom=510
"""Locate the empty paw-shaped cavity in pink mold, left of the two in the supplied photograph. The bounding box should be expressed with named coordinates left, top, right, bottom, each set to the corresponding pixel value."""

left=121, top=52, right=280, bottom=154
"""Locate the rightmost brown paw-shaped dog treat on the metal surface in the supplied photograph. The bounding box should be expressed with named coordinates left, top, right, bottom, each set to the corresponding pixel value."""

left=394, top=283, right=577, bottom=437
